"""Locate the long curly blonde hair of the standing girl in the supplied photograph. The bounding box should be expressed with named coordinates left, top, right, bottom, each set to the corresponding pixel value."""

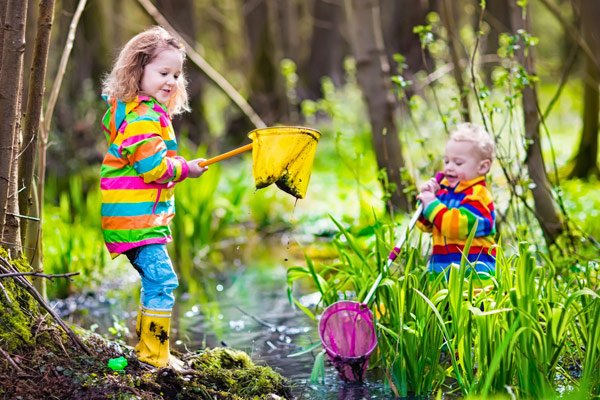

left=102, top=26, right=189, bottom=115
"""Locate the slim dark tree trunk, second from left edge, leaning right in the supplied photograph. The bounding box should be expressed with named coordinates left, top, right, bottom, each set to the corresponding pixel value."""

left=19, top=0, right=54, bottom=244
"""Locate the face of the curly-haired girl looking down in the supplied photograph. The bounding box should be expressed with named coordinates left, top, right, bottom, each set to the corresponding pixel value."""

left=140, top=48, right=183, bottom=105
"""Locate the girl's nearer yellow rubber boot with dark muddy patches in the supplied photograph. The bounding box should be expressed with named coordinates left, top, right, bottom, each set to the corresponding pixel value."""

left=135, top=308, right=171, bottom=368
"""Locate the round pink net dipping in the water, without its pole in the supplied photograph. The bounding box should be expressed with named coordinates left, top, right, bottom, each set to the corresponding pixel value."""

left=319, top=301, right=377, bottom=382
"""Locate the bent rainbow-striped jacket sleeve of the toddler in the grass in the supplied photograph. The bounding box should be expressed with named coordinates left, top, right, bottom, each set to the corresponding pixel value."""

left=423, top=186, right=496, bottom=240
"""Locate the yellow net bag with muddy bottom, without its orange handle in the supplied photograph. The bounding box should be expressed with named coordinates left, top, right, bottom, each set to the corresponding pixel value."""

left=248, top=126, right=321, bottom=199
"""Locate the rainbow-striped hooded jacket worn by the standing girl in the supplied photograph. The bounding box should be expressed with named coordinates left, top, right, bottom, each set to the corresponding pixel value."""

left=100, top=96, right=188, bottom=258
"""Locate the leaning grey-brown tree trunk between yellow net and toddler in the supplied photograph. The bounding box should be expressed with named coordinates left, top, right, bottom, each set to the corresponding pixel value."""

left=345, top=0, right=410, bottom=212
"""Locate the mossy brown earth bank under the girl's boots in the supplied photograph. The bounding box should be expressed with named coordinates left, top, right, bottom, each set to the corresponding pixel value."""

left=0, top=319, right=291, bottom=400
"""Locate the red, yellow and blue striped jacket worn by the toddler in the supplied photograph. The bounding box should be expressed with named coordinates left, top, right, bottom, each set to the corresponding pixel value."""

left=417, top=176, right=496, bottom=278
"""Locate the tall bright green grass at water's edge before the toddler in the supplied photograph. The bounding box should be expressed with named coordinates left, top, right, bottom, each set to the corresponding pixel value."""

left=288, top=217, right=600, bottom=399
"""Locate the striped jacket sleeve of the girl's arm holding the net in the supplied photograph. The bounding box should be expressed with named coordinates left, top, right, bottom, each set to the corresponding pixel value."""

left=119, top=120, right=189, bottom=183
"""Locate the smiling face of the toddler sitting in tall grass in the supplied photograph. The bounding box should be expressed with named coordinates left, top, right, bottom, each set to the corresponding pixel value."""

left=444, top=140, right=491, bottom=186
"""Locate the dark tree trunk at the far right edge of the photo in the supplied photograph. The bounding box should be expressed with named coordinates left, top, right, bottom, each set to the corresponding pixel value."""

left=570, top=0, right=600, bottom=178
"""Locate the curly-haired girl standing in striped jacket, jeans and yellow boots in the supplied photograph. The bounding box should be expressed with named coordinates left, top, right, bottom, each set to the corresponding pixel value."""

left=100, top=27, right=207, bottom=368
